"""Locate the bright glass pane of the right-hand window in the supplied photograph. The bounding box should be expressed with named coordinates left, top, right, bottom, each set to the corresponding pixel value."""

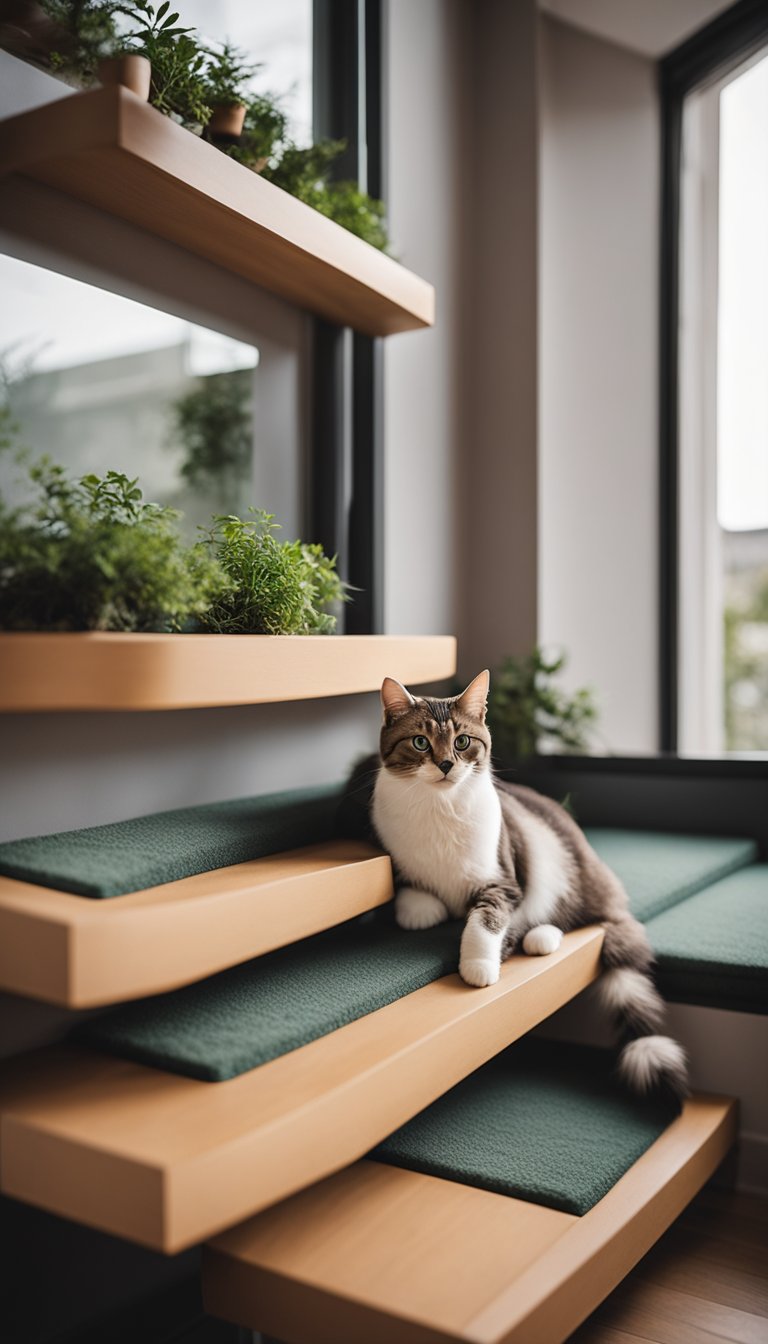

left=717, top=56, right=768, bottom=751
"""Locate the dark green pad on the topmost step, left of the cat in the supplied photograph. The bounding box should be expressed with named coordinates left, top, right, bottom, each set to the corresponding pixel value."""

left=0, top=785, right=342, bottom=896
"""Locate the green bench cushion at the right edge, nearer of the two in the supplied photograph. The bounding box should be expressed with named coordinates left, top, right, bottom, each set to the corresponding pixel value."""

left=648, top=863, right=768, bottom=1013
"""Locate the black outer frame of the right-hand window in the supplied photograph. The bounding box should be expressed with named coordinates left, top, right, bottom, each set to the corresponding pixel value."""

left=659, top=0, right=768, bottom=753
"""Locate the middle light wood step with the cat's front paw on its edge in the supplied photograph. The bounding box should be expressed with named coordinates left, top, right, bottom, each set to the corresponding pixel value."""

left=0, top=929, right=603, bottom=1253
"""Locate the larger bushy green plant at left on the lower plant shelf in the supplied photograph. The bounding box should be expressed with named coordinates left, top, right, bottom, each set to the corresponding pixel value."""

left=0, top=458, right=229, bottom=630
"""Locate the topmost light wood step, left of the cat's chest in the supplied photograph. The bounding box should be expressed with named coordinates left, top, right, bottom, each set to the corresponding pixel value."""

left=0, top=840, right=393, bottom=1008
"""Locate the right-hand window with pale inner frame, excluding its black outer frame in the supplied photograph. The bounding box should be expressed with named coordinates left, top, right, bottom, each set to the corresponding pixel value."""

left=678, top=52, right=768, bottom=754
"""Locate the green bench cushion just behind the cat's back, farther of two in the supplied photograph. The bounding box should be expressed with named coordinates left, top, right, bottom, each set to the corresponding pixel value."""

left=585, top=827, right=757, bottom=921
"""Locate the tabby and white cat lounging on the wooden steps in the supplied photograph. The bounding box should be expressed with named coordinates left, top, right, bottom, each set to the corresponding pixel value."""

left=371, top=672, right=687, bottom=1098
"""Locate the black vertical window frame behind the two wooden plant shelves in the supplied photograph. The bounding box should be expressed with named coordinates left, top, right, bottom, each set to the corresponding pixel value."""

left=308, top=0, right=386, bottom=634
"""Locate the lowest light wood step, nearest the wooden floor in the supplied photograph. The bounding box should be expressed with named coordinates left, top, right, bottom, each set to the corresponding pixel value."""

left=203, top=1097, right=736, bottom=1344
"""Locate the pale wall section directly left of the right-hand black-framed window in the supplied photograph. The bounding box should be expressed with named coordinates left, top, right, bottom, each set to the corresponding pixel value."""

left=538, top=17, right=659, bottom=753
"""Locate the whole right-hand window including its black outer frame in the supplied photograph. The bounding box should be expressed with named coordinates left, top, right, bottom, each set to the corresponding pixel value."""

left=659, top=0, right=768, bottom=755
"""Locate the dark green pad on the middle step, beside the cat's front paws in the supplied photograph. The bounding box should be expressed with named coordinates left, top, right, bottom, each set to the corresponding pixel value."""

left=81, top=906, right=461, bottom=1082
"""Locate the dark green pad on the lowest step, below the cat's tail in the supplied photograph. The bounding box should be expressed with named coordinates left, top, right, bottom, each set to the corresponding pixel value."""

left=371, top=1038, right=671, bottom=1214
